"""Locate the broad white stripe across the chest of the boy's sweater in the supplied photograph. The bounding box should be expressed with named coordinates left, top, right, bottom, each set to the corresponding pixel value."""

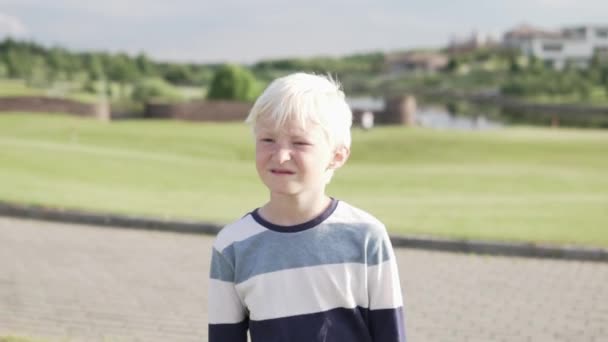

left=236, top=263, right=368, bottom=320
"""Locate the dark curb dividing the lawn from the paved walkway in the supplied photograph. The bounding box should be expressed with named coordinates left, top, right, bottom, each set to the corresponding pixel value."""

left=0, top=201, right=608, bottom=262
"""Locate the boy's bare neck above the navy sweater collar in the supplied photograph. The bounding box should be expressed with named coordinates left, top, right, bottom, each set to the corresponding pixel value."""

left=258, top=193, right=331, bottom=226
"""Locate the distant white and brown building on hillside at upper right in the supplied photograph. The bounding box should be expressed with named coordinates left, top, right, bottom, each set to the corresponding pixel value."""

left=503, top=25, right=608, bottom=69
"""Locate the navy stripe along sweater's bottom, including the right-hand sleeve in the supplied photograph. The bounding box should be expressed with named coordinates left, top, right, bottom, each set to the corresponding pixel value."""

left=249, top=307, right=405, bottom=342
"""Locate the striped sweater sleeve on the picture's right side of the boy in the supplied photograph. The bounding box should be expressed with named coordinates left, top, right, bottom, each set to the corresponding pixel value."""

left=368, top=230, right=405, bottom=342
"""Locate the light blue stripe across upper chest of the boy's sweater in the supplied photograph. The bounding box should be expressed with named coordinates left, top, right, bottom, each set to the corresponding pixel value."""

left=230, top=224, right=390, bottom=284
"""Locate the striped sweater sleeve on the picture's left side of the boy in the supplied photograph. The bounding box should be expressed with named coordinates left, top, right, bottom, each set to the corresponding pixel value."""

left=208, top=248, right=249, bottom=342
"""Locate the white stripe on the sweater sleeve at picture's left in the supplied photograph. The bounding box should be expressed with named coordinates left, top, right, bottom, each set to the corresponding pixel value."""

left=208, top=279, right=246, bottom=324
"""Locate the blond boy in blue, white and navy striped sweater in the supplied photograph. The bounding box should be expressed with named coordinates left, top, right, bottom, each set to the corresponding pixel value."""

left=209, top=73, right=405, bottom=342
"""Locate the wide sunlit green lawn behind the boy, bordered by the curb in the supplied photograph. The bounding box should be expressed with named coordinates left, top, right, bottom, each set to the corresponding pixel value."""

left=0, top=113, right=608, bottom=246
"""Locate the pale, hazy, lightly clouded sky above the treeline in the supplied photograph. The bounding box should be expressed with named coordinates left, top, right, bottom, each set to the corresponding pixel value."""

left=0, top=0, right=608, bottom=63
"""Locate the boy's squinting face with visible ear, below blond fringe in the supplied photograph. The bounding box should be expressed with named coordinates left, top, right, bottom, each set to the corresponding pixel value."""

left=255, top=119, right=348, bottom=196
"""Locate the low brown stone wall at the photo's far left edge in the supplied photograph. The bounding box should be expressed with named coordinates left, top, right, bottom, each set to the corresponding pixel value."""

left=0, top=96, right=110, bottom=120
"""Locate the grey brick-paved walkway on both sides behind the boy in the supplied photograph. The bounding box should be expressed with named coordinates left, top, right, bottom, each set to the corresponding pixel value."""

left=0, top=217, right=608, bottom=342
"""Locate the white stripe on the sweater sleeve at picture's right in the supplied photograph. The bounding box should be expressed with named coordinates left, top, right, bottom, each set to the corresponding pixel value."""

left=367, top=257, right=403, bottom=310
